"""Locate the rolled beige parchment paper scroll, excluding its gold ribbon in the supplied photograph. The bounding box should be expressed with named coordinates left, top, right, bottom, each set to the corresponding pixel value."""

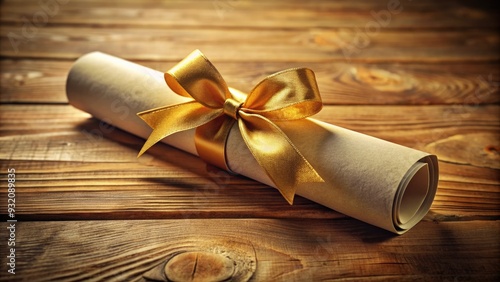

left=66, top=52, right=438, bottom=234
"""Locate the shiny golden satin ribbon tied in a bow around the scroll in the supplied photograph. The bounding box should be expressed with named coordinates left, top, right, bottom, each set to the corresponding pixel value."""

left=137, top=50, right=324, bottom=204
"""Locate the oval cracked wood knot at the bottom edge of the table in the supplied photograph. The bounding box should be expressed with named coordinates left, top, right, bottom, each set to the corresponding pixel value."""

left=165, top=252, right=235, bottom=282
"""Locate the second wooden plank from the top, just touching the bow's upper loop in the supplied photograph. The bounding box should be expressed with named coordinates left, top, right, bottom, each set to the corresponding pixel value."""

left=0, top=26, right=500, bottom=63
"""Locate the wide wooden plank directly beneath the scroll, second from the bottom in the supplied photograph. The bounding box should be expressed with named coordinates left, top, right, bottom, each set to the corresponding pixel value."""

left=0, top=105, right=500, bottom=219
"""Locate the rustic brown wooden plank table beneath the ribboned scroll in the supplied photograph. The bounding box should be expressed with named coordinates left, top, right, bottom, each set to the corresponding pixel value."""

left=0, top=0, right=500, bottom=281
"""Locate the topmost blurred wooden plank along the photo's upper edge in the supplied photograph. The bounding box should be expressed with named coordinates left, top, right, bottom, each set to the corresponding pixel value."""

left=0, top=0, right=499, bottom=29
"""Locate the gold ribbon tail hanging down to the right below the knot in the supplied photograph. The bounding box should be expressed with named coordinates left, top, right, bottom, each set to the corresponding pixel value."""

left=238, top=112, right=324, bottom=204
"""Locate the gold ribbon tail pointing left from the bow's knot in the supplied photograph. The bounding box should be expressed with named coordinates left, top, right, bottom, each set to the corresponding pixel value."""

left=137, top=101, right=222, bottom=157
